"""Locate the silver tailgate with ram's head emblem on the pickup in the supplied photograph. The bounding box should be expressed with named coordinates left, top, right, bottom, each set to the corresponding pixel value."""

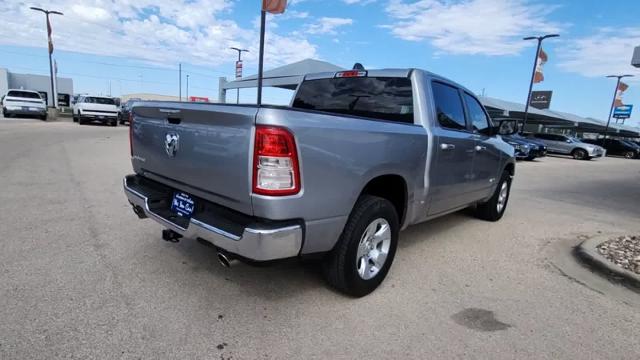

left=131, top=102, right=258, bottom=215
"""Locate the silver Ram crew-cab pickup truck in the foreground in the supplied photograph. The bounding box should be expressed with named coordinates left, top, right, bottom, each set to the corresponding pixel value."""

left=124, top=69, right=516, bottom=296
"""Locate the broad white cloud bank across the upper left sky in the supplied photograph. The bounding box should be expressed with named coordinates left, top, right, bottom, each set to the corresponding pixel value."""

left=0, top=0, right=317, bottom=67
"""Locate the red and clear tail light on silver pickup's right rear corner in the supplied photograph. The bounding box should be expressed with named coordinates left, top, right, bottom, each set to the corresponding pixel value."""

left=252, top=125, right=300, bottom=196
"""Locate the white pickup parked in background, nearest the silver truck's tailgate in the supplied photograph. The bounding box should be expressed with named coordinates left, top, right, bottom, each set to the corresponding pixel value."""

left=73, top=95, right=120, bottom=126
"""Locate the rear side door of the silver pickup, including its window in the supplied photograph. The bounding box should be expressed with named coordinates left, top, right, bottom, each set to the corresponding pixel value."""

left=429, top=80, right=476, bottom=215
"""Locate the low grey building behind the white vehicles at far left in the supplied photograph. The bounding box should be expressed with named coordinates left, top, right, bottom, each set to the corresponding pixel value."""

left=0, top=68, right=73, bottom=106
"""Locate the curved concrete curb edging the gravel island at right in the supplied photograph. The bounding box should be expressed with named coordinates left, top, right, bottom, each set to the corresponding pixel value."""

left=573, top=236, right=640, bottom=292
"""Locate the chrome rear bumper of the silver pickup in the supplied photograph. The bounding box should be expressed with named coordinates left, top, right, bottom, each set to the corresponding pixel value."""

left=123, top=175, right=303, bottom=261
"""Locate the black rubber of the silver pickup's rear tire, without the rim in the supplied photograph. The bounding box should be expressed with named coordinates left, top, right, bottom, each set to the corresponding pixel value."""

left=323, top=195, right=400, bottom=297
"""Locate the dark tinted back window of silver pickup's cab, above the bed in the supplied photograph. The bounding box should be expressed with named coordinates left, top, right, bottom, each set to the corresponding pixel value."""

left=293, top=77, right=413, bottom=123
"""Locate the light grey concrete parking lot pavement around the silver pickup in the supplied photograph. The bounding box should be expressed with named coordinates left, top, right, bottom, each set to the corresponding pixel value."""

left=0, top=118, right=640, bottom=359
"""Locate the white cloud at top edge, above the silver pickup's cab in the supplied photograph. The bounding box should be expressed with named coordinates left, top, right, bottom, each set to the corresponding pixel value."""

left=383, top=0, right=560, bottom=56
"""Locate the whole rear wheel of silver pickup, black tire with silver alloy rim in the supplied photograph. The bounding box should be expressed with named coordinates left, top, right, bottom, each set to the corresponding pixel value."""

left=323, top=195, right=400, bottom=297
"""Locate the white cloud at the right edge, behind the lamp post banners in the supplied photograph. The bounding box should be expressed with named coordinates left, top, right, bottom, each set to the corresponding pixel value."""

left=558, top=27, right=640, bottom=80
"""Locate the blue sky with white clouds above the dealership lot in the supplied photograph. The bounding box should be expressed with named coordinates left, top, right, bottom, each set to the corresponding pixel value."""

left=0, top=0, right=640, bottom=126
